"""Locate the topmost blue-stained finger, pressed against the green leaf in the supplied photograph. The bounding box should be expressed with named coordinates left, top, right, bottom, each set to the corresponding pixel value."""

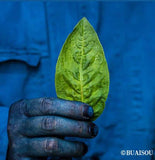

left=25, top=98, right=93, bottom=120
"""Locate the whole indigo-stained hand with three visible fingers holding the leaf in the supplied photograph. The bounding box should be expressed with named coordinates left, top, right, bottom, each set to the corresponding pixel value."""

left=7, top=98, right=98, bottom=160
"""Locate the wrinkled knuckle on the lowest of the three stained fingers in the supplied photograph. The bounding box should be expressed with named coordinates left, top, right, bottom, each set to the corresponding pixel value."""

left=44, top=138, right=58, bottom=153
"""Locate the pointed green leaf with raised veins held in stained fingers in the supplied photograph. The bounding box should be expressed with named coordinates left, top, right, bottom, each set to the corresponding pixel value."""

left=55, top=17, right=109, bottom=120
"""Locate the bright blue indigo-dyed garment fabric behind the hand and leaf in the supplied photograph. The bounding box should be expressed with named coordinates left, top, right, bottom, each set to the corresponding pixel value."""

left=0, top=1, right=155, bottom=160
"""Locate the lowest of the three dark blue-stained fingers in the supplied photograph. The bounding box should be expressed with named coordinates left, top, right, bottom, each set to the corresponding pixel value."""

left=25, top=138, right=87, bottom=157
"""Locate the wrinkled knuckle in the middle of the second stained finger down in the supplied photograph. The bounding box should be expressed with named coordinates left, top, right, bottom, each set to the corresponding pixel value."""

left=41, top=116, right=56, bottom=131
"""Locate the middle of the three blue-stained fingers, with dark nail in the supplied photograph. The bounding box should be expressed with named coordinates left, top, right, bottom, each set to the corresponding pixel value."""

left=22, top=116, right=98, bottom=138
